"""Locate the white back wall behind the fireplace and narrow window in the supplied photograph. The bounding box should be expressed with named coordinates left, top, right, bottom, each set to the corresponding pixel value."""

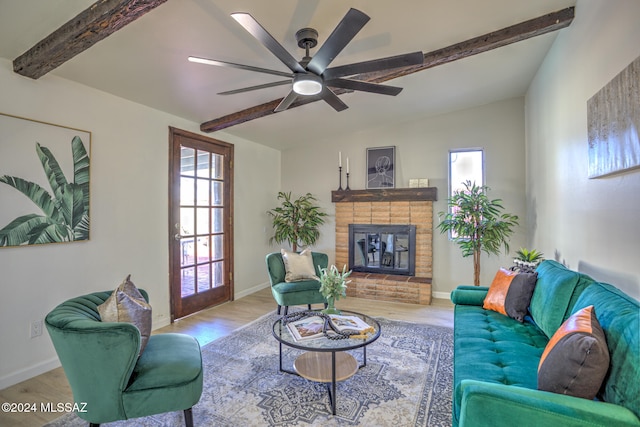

left=282, top=98, right=526, bottom=298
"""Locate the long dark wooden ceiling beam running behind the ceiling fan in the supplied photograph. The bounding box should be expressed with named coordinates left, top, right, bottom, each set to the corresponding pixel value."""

left=200, top=7, right=575, bottom=132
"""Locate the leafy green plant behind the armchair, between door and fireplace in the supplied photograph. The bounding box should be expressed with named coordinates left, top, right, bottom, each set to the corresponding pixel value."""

left=267, top=191, right=327, bottom=252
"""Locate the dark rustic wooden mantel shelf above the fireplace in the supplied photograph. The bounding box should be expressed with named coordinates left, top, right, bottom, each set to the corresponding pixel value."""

left=331, top=187, right=438, bottom=203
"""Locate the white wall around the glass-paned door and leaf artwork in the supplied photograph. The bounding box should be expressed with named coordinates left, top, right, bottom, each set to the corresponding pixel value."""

left=0, top=59, right=280, bottom=389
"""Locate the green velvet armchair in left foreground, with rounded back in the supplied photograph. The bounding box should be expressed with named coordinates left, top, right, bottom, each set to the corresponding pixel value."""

left=45, top=290, right=203, bottom=427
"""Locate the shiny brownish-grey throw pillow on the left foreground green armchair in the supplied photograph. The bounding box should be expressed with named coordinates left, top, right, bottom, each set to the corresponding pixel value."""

left=98, top=275, right=152, bottom=355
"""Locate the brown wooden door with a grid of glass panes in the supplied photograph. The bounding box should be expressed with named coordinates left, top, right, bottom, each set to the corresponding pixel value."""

left=170, top=129, right=233, bottom=319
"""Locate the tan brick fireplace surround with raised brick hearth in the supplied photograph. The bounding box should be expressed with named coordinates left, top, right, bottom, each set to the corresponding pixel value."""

left=331, top=187, right=437, bottom=305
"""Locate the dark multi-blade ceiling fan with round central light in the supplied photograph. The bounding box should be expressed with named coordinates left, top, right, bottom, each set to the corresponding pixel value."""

left=189, top=9, right=424, bottom=112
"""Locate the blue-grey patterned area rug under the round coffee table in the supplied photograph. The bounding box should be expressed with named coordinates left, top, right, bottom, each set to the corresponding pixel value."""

left=47, top=314, right=453, bottom=427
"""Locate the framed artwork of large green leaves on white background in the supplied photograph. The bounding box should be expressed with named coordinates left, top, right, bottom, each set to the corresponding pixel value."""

left=0, top=113, right=91, bottom=247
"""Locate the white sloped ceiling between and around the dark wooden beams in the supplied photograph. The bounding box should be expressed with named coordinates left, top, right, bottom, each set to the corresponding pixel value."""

left=0, top=0, right=576, bottom=149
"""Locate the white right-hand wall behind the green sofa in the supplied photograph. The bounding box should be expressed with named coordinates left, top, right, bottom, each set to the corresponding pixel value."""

left=526, top=0, right=640, bottom=298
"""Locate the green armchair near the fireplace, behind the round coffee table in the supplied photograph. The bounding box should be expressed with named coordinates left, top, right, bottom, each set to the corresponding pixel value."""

left=266, top=252, right=329, bottom=315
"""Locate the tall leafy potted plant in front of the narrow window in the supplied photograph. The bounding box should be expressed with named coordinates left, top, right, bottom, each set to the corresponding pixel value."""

left=438, top=181, right=518, bottom=286
